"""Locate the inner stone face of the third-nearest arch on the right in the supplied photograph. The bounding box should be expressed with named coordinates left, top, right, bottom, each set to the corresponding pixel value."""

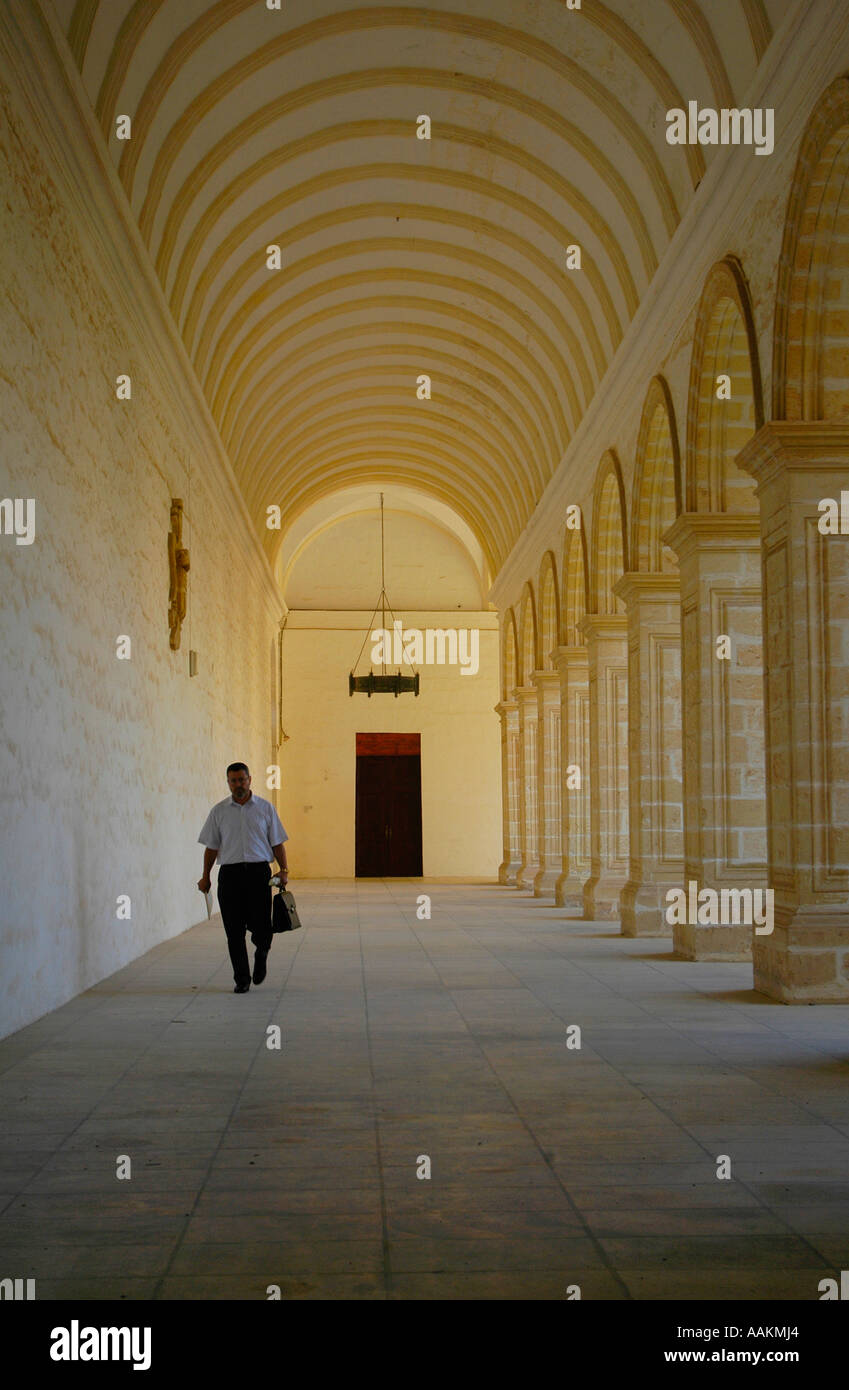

left=631, top=377, right=684, bottom=574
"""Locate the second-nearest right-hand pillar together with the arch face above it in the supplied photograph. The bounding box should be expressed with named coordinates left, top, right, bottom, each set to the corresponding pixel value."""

left=667, top=256, right=767, bottom=960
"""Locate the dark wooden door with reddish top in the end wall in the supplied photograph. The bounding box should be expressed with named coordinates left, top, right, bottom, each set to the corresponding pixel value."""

left=356, top=734, right=421, bottom=878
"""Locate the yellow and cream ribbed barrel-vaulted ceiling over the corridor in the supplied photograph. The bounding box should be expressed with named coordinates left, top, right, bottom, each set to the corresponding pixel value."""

left=53, top=0, right=789, bottom=574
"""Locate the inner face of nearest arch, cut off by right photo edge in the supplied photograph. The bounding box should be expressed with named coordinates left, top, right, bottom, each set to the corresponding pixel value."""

left=773, top=76, right=849, bottom=420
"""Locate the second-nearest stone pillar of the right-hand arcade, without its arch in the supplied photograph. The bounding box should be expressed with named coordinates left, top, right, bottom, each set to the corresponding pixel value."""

left=664, top=512, right=766, bottom=960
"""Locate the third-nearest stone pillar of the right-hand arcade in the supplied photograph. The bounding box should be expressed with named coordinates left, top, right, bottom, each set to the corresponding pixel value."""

left=614, top=573, right=684, bottom=937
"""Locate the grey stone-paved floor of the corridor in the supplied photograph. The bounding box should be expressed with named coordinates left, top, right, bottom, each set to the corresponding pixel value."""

left=0, top=880, right=849, bottom=1300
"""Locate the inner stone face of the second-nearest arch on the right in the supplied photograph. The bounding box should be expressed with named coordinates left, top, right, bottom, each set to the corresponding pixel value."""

left=686, top=256, right=764, bottom=516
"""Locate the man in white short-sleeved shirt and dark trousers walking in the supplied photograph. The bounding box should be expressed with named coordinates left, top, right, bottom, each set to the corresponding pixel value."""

left=197, top=763, right=289, bottom=994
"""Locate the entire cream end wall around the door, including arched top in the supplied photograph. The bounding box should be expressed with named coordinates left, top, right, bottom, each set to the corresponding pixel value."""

left=281, top=511, right=502, bottom=880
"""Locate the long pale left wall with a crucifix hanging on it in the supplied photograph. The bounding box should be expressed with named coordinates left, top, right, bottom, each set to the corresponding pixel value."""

left=0, top=70, right=282, bottom=1034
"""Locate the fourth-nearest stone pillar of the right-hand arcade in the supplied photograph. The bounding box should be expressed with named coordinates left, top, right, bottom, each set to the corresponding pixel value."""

left=578, top=613, right=628, bottom=922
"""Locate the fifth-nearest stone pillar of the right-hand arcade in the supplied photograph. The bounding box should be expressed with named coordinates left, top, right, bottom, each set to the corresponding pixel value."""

left=552, top=646, right=589, bottom=916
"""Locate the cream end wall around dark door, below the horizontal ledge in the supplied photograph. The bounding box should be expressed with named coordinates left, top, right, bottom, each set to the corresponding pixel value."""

left=281, top=610, right=502, bottom=881
